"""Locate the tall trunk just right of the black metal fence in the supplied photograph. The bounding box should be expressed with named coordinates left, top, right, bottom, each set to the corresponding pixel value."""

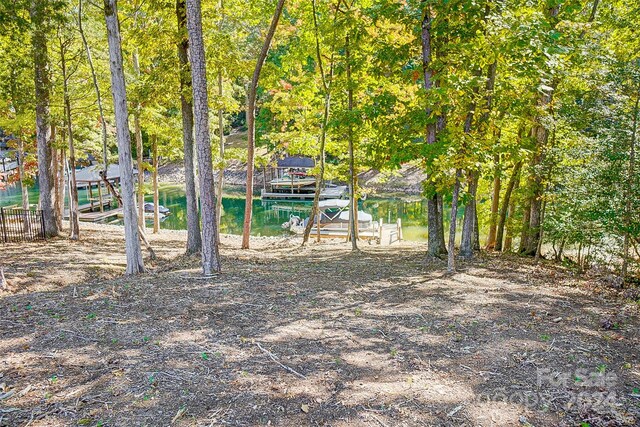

left=31, top=0, right=60, bottom=237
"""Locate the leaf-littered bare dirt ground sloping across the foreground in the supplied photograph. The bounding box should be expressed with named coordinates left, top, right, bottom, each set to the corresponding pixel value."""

left=0, top=226, right=640, bottom=427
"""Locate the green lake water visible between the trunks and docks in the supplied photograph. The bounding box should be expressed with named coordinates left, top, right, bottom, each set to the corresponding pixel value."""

left=0, top=184, right=436, bottom=241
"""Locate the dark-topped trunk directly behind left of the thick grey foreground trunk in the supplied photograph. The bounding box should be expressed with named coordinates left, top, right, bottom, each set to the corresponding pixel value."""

left=176, top=0, right=202, bottom=255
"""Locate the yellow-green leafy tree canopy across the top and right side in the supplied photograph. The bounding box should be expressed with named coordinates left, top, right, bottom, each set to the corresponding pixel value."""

left=0, top=0, right=640, bottom=274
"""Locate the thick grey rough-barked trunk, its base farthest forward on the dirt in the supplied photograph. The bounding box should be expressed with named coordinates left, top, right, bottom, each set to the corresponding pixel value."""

left=186, top=0, right=221, bottom=275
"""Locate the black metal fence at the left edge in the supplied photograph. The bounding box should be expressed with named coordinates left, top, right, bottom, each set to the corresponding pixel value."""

left=0, top=208, right=46, bottom=243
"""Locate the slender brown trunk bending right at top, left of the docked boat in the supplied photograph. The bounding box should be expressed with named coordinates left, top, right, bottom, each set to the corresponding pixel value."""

left=242, top=0, right=285, bottom=249
